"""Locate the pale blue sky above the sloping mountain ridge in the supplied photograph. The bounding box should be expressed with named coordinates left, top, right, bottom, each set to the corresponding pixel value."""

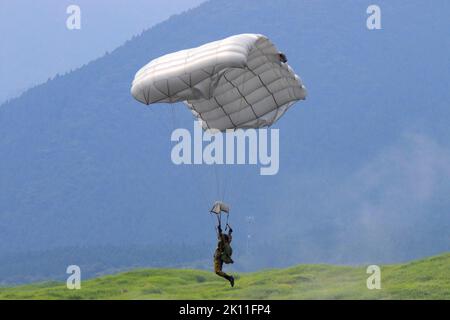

left=0, top=0, right=203, bottom=104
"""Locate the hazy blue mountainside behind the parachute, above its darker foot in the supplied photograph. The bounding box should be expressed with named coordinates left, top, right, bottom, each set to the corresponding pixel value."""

left=0, top=0, right=450, bottom=276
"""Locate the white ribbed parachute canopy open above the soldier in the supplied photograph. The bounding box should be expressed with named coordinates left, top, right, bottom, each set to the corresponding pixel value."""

left=131, top=34, right=306, bottom=131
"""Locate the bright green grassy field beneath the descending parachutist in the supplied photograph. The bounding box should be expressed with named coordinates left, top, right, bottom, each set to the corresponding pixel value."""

left=0, top=253, right=450, bottom=299
